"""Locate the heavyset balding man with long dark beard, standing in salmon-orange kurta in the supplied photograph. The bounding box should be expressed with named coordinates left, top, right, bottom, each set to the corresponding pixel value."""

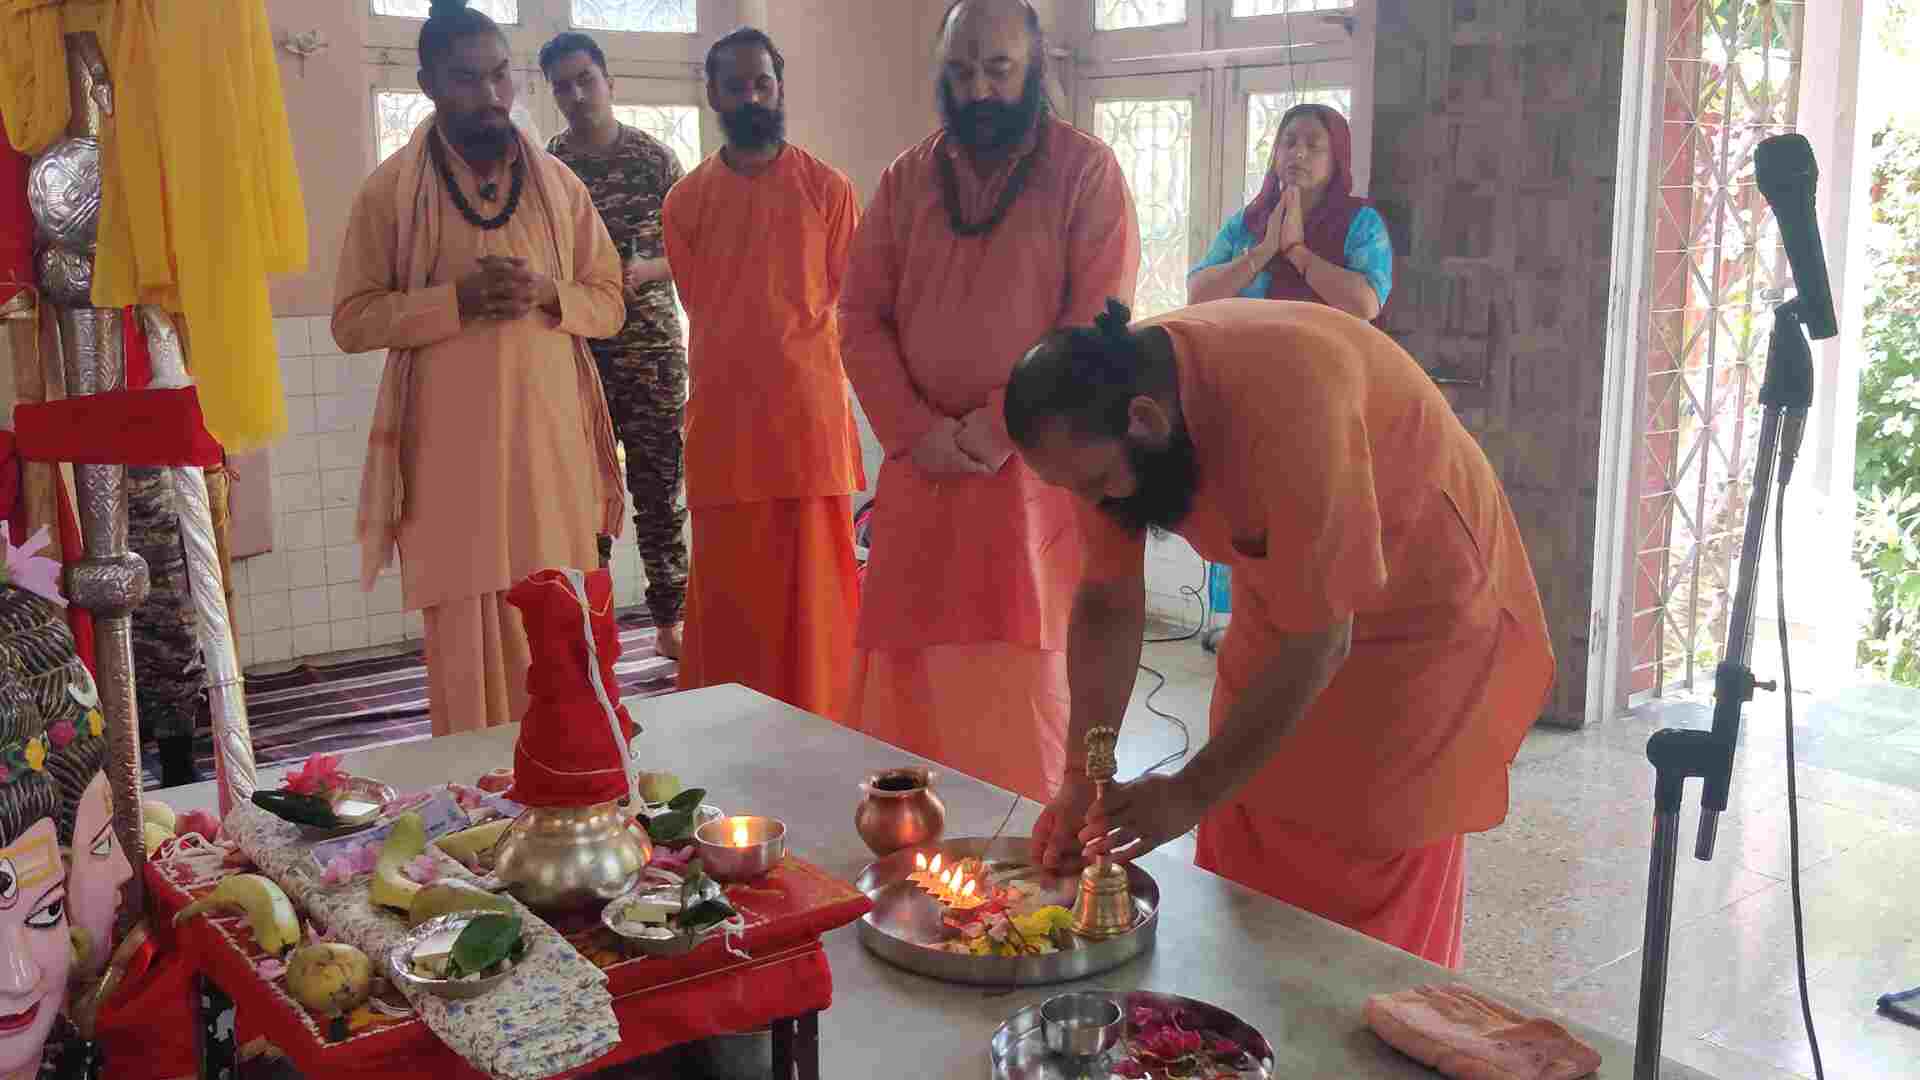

left=841, top=0, right=1140, bottom=799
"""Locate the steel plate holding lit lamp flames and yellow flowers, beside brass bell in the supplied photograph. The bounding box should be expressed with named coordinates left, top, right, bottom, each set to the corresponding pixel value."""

left=854, top=836, right=1160, bottom=986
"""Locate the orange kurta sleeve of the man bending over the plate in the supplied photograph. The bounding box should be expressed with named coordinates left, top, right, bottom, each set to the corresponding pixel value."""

left=1233, top=343, right=1386, bottom=634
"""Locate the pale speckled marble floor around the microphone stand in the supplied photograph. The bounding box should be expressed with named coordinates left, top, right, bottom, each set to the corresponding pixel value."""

left=1119, top=630, right=1920, bottom=1080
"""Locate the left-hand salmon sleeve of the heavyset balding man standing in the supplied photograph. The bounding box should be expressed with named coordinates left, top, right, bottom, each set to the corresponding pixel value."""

left=839, top=163, right=944, bottom=457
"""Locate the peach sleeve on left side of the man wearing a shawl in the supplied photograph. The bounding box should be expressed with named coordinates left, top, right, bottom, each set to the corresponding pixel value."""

left=334, top=171, right=461, bottom=352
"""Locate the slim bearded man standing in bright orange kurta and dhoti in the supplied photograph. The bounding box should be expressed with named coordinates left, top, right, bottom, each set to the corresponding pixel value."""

left=664, top=29, right=866, bottom=717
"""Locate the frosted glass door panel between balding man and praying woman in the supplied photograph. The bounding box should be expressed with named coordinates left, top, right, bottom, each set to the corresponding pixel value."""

left=1079, top=71, right=1215, bottom=319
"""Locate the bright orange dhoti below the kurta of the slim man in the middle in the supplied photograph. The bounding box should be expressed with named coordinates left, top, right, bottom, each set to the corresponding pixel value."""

left=680, top=496, right=860, bottom=717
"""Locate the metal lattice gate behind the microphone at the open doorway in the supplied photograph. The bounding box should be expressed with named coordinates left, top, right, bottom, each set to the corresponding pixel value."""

left=1628, top=0, right=1803, bottom=694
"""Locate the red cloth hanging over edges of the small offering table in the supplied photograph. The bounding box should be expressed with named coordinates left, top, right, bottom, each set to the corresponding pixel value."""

left=142, top=857, right=872, bottom=1080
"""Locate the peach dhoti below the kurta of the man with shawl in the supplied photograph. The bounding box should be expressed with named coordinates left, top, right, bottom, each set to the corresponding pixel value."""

left=422, top=592, right=532, bottom=736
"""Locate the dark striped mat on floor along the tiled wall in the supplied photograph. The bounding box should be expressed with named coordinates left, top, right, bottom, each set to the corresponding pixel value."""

left=146, top=613, right=678, bottom=790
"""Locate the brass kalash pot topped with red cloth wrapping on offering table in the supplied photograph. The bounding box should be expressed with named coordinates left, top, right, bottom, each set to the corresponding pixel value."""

left=493, top=569, right=653, bottom=911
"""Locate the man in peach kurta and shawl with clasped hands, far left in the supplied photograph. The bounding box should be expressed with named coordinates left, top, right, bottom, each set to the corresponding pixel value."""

left=332, top=8, right=626, bottom=734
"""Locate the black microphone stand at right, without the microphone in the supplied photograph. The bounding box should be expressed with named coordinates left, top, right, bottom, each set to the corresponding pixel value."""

left=1634, top=300, right=1812, bottom=1080
